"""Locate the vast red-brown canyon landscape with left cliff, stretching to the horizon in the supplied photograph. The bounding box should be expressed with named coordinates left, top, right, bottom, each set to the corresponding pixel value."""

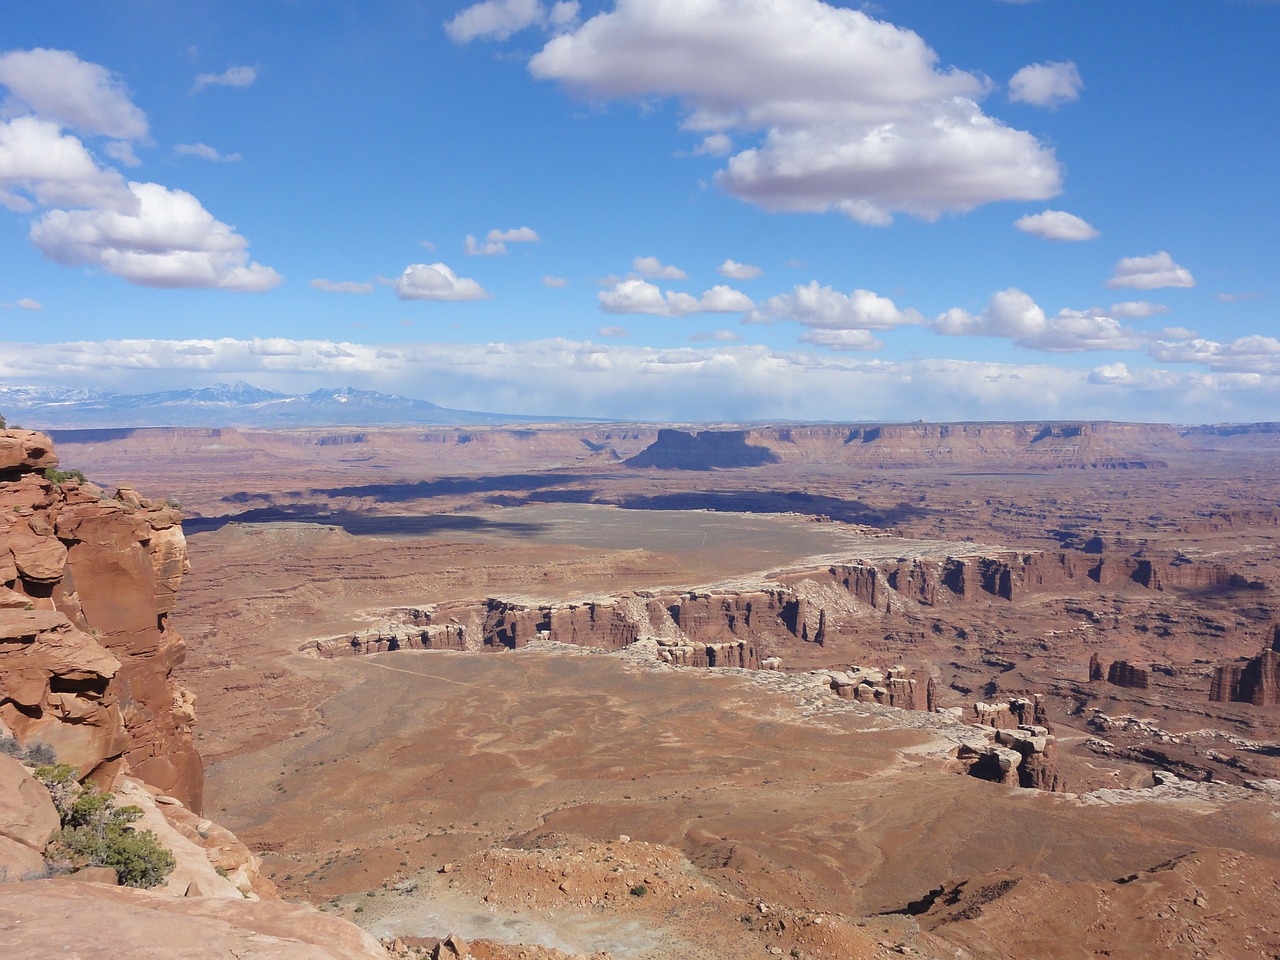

left=0, top=422, right=1280, bottom=960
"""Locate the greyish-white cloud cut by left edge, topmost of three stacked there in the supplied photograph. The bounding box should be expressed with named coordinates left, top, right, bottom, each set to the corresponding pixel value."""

left=0, top=47, right=147, bottom=141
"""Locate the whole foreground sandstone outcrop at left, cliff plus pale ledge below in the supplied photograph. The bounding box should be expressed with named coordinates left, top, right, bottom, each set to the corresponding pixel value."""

left=0, top=430, right=387, bottom=960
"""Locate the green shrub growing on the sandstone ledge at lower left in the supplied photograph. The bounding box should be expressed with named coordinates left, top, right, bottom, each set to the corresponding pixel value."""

left=36, top=763, right=177, bottom=888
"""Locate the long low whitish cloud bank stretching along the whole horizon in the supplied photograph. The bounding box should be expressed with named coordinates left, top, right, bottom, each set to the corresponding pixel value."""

left=0, top=338, right=1280, bottom=422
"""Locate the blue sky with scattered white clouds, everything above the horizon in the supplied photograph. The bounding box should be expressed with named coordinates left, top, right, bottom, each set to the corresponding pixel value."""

left=0, top=0, right=1280, bottom=421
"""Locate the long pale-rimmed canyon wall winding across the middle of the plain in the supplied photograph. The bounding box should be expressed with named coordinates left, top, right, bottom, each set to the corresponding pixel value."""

left=307, top=552, right=1244, bottom=686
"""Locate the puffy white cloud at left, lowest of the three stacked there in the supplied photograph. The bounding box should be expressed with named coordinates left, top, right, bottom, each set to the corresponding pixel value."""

left=31, top=183, right=283, bottom=292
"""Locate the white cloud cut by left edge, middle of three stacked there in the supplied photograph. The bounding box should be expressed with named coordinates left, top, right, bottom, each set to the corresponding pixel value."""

left=0, top=116, right=137, bottom=211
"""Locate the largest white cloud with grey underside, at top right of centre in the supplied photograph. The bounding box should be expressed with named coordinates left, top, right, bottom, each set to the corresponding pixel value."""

left=530, top=0, right=1061, bottom=224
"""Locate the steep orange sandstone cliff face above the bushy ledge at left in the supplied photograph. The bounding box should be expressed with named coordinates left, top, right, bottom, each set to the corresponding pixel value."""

left=0, top=430, right=204, bottom=810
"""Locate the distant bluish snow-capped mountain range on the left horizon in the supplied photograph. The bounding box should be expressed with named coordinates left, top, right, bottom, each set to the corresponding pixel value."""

left=0, top=381, right=573, bottom=430
